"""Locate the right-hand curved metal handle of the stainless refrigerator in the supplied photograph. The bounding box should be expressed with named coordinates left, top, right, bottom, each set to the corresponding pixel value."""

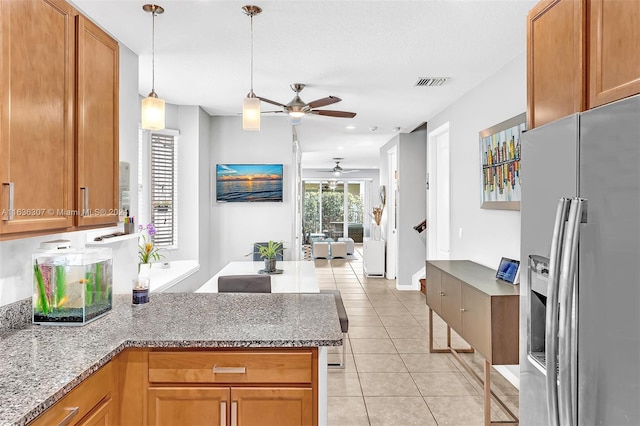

left=558, top=198, right=586, bottom=426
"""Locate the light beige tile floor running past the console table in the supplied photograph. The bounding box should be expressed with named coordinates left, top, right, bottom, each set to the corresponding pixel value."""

left=315, top=245, right=518, bottom=426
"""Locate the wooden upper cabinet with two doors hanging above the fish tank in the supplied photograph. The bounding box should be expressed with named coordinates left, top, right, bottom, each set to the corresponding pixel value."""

left=0, top=0, right=119, bottom=238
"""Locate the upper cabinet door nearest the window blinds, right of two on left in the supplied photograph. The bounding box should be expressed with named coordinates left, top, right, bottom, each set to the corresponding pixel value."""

left=76, top=16, right=119, bottom=226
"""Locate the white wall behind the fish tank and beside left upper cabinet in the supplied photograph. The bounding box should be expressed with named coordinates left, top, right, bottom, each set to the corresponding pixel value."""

left=0, top=44, right=140, bottom=305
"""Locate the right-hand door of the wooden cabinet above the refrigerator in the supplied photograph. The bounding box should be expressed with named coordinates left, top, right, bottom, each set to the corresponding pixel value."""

left=589, top=0, right=640, bottom=108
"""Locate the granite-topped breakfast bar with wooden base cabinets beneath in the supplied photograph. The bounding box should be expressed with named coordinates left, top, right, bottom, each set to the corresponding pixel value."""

left=0, top=293, right=343, bottom=425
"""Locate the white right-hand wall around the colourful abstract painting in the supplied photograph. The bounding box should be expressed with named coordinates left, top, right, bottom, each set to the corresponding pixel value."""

left=426, top=52, right=527, bottom=384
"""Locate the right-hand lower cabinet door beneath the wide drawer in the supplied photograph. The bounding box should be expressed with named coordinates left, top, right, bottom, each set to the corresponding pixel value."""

left=231, top=388, right=317, bottom=426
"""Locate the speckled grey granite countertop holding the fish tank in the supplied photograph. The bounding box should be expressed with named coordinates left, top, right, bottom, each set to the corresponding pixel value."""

left=0, top=293, right=342, bottom=425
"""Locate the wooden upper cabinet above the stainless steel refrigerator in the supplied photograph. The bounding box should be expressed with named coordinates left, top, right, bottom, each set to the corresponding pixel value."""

left=527, top=0, right=640, bottom=129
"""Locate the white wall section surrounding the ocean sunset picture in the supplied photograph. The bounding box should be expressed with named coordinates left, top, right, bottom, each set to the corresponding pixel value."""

left=210, top=116, right=297, bottom=275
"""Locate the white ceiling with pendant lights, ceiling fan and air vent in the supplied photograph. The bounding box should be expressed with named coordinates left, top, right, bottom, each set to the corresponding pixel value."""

left=72, top=0, right=537, bottom=168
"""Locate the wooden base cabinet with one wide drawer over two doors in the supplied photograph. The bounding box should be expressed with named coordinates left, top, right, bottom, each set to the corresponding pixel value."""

left=145, top=348, right=318, bottom=426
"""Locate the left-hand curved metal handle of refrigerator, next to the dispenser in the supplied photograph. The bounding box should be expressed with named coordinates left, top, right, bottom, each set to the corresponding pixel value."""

left=545, top=198, right=570, bottom=426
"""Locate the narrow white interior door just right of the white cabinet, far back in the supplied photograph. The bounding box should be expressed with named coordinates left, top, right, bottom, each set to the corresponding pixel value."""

left=385, top=146, right=398, bottom=280
